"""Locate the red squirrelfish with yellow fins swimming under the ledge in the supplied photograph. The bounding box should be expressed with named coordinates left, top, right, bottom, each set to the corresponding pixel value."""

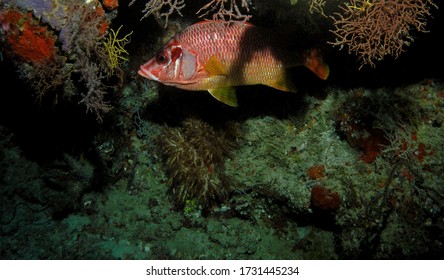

left=138, top=21, right=329, bottom=106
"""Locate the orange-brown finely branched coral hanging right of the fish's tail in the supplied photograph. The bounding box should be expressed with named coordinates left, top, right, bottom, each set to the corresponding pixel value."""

left=330, top=0, right=438, bottom=67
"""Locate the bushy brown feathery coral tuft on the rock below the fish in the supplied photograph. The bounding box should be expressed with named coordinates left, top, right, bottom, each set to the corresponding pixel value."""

left=158, top=118, right=237, bottom=208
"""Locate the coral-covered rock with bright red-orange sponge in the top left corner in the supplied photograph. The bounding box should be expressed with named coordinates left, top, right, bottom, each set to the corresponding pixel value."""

left=0, top=0, right=128, bottom=121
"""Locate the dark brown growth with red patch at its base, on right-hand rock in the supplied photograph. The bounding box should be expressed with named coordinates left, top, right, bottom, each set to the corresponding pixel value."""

left=335, top=86, right=422, bottom=163
